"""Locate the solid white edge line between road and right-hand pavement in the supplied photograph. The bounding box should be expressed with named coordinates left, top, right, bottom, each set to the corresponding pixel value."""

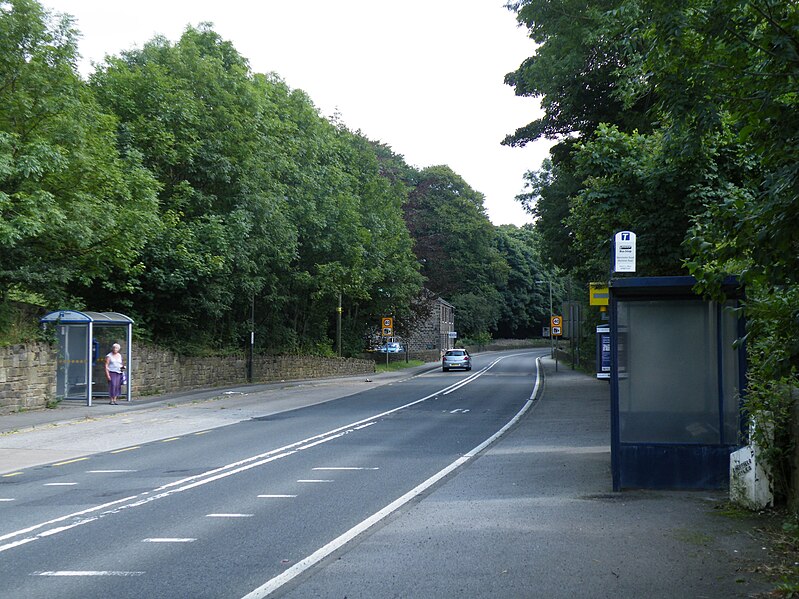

left=242, top=358, right=541, bottom=599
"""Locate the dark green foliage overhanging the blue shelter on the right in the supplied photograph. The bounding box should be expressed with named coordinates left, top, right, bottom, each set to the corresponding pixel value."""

left=506, top=0, right=799, bottom=502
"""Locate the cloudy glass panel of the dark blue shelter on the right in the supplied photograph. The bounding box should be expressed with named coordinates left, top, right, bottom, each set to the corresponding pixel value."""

left=617, top=299, right=740, bottom=445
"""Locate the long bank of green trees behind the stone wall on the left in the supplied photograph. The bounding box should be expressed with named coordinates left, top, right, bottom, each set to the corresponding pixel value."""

left=0, top=0, right=542, bottom=355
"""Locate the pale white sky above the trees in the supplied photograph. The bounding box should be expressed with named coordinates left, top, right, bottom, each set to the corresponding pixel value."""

left=43, top=0, right=551, bottom=225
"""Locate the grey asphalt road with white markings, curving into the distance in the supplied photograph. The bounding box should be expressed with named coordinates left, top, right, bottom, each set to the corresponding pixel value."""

left=0, top=350, right=546, bottom=598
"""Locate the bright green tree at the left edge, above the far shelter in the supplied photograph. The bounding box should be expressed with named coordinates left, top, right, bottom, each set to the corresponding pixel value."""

left=0, top=0, right=156, bottom=305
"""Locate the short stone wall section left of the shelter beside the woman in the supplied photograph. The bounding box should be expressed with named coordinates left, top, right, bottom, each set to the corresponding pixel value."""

left=0, top=343, right=56, bottom=414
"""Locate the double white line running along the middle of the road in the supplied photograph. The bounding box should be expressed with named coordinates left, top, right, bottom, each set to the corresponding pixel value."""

left=0, top=354, right=538, bottom=553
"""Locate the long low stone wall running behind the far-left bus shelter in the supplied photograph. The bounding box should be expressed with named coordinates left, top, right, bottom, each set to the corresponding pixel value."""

left=0, top=343, right=375, bottom=415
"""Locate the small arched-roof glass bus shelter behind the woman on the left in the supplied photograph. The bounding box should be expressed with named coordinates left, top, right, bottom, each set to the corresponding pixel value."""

left=39, top=310, right=133, bottom=406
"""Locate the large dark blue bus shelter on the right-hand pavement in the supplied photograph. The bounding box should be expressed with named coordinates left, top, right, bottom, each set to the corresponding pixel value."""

left=610, top=277, right=746, bottom=491
